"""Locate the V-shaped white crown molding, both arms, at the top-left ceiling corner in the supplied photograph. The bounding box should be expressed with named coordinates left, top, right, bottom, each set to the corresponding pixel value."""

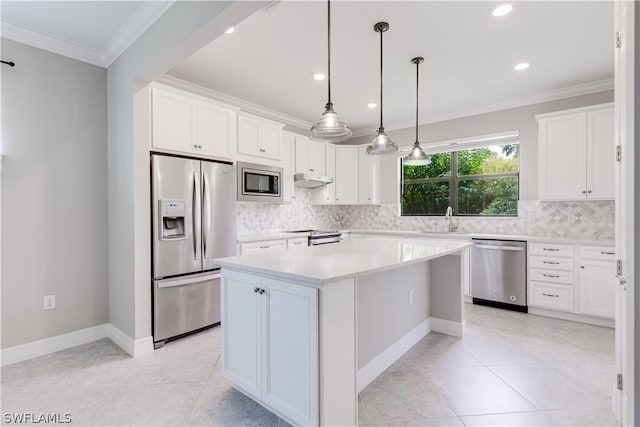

left=1, top=0, right=176, bottom=68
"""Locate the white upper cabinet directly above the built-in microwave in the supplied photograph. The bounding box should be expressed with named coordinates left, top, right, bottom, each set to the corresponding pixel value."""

left=238, top=113, right=284, bottom=160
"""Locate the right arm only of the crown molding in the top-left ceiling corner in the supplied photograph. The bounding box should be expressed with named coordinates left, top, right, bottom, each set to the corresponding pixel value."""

left=100, top=0, right=176, bottom=67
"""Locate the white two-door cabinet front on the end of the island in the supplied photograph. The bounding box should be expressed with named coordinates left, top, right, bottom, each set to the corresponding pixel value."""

left=222, top=271, right=319, bottom=425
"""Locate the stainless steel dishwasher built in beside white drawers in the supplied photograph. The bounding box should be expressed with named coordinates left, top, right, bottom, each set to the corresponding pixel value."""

left=471, top=239, right=527, bottom=313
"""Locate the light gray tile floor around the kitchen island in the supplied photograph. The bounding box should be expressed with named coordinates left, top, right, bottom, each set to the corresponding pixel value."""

left=0, top=305, right=615, bottom=427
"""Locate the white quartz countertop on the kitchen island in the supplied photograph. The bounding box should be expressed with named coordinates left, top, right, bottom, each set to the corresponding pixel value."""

left=216, top=237, right=470, bottom=285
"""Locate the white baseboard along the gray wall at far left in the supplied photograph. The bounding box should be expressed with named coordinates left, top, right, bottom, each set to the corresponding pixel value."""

left=0, top=323, right=109, bottom=366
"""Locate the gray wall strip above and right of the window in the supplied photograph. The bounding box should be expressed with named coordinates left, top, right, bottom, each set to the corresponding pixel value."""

left=349, top=90, right=613, bottom=200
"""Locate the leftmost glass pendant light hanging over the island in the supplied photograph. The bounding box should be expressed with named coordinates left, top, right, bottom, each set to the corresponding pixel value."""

left=309, top=0, right=351, bottom=143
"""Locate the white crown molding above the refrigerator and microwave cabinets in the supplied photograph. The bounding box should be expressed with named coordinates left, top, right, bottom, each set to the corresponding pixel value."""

left=155, top=74, right=313, bottom=129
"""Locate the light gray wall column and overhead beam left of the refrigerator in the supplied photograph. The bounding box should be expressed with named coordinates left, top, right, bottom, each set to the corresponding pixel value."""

left=107, top=1, right=268, bottom=340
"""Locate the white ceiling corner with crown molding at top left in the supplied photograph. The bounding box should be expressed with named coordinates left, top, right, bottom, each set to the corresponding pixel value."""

left=0, top=0, right=173, bottom=67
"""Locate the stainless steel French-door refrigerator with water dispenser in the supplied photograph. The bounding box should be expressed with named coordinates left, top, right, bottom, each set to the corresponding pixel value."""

left=151, top=154, right=237, bottom=347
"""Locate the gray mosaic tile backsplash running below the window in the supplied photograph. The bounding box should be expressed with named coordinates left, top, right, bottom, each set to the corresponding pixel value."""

left=237, top=193, right=614, bottom=239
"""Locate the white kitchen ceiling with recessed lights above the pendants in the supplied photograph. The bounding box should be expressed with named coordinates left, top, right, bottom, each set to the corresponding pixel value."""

left=168, top=0, right=614, bottom=134
